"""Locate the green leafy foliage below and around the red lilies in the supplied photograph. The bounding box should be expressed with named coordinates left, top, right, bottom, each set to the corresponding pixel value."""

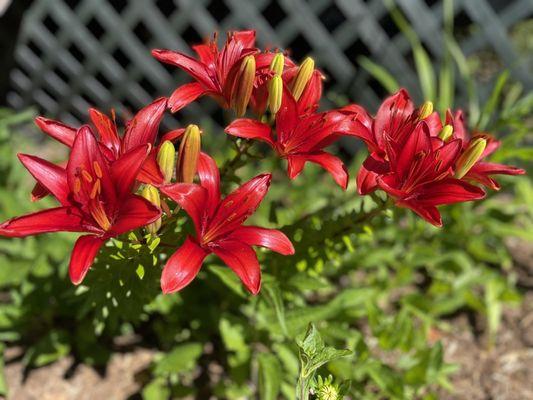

left=0, top=3, right=533, bottom=400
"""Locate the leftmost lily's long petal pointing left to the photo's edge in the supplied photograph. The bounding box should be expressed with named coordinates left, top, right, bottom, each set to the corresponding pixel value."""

left=0, top=207, right=90, bottom=237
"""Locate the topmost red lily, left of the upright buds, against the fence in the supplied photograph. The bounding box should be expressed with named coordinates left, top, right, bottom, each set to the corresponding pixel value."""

left=152, top=31, right=258, bottom=112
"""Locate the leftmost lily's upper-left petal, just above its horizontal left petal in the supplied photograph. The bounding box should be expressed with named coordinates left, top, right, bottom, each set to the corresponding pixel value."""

left=18, top=154, right=70, bottom=206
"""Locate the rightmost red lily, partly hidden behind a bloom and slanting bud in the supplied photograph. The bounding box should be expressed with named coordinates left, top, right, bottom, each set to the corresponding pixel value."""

left=446, top=110, right=526, bottom=190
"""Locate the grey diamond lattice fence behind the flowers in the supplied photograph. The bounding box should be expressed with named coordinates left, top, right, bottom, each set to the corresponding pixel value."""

left=8, top=0, right=533, bottom=131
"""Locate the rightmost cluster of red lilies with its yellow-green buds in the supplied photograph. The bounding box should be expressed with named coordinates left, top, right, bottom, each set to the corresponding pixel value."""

left=343, top=90, right=525, bottom=226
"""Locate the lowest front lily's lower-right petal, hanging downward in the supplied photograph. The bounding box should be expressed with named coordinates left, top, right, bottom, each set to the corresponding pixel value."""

left=212, top=240, right=261, bottom=295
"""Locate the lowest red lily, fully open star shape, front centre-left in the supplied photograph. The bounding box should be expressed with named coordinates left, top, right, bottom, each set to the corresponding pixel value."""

left=161, top=153, right=294, bottom=294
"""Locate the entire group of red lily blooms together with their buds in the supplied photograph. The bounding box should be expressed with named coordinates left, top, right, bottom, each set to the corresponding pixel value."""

left=0, top=31, right=524, bottom=294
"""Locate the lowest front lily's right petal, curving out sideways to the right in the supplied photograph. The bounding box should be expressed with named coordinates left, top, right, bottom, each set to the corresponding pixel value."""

left=225, top=226, right=294, bottom=256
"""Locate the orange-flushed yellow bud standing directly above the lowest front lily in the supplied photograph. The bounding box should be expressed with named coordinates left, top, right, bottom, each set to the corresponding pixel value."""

left=176, top=125, right=202, bottom=183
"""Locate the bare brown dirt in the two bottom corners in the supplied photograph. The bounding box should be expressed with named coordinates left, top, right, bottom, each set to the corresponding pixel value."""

left=5, top=242, right=533, bottom=400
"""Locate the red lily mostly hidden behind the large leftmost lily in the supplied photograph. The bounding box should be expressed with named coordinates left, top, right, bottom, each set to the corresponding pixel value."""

left=32, top=98, right=175, bottom=191
